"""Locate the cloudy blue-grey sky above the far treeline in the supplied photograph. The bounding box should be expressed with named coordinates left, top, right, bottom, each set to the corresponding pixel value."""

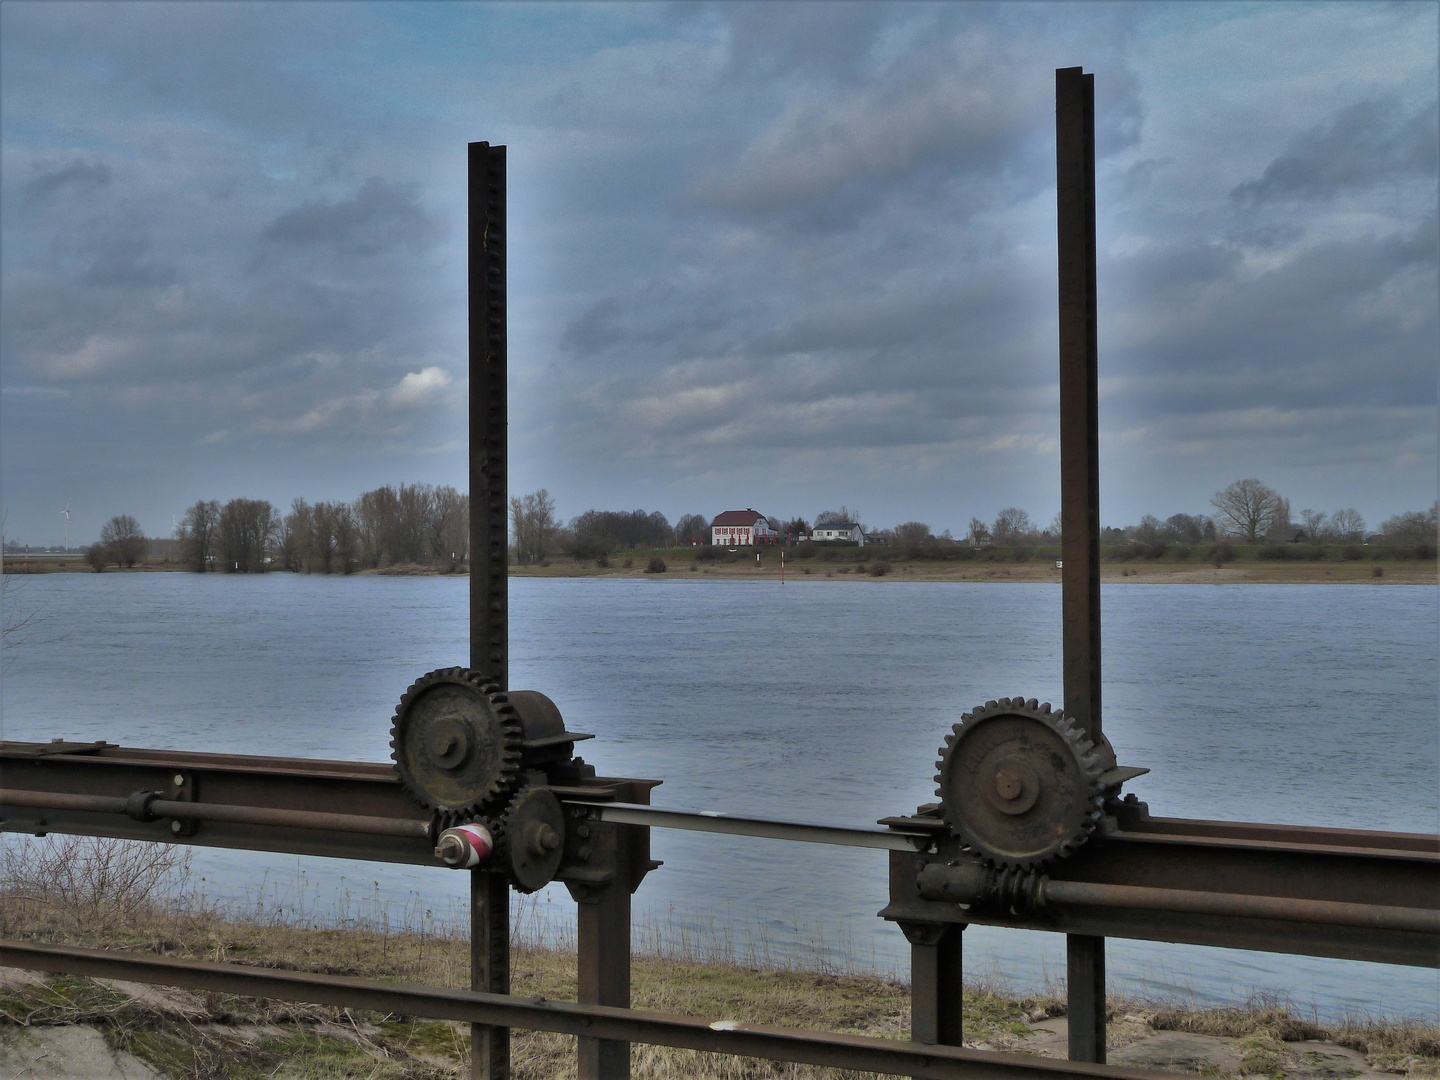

left=0, top=1, right=1437, bottom=543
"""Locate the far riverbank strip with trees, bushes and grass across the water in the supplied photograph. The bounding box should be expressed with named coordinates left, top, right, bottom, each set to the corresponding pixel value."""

left=6, top=480, right=1440, bottom=580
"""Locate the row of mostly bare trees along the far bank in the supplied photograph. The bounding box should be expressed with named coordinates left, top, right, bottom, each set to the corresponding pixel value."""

left=86, top=478, right=1440, bottom=573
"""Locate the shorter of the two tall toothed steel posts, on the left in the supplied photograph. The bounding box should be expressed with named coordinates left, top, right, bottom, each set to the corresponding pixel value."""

left=468, top=143, right=510, bottom=1080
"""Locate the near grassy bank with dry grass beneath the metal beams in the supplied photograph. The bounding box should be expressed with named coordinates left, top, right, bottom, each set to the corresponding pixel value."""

left=0, top=841, right=1440, bottom=1080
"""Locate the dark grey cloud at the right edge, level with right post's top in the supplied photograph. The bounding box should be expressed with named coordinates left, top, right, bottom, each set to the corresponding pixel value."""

left=1230, top=99, right=1437, bottom=204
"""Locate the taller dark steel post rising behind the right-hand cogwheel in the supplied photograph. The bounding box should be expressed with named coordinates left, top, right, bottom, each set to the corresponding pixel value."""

left=1056, top=68, right=1104, bottom=1063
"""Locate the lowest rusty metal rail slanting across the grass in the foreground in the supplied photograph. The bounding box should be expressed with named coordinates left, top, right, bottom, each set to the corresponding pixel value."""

left=0, top=940, right=1168, bottom=1080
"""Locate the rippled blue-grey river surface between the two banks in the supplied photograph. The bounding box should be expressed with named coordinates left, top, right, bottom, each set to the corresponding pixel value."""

left=0, top=573, right=1440, bottom=1020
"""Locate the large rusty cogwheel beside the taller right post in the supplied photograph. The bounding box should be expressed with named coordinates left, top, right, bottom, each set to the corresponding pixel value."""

left=935, top=697, right=1107, bottom=870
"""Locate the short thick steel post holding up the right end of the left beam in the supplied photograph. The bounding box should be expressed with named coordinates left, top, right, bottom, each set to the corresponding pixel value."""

left=576, top=880, right=631, bottom=1080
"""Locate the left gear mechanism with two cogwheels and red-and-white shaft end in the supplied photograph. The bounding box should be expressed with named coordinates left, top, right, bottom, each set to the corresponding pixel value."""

left=390, top=668, right=595, bottom=893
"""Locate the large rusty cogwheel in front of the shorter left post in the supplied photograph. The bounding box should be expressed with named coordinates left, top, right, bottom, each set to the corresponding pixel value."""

left=390, top=668, right=524, bottom=818
